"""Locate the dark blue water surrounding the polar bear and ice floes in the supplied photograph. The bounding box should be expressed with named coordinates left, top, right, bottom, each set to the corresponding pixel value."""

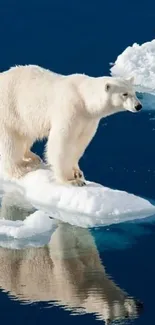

left=0, top=0, right=155, bottom=325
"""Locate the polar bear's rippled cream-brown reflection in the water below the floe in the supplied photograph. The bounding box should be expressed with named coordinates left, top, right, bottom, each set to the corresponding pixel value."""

left=0, top=193, right=142, bottom=324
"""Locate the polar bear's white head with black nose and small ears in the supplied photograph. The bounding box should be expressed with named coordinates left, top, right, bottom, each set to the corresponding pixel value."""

left=105, top=77, right=142, bottom=113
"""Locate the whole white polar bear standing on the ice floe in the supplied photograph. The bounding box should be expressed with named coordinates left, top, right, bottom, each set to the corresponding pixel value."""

left=0, top=65, right=142, bottom=186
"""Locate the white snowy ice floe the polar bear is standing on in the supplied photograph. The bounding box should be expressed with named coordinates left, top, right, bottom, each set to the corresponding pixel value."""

left=0, top=159, right=155, bottom=248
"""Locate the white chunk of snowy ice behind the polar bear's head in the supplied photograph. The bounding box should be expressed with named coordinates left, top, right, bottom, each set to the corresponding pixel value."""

left=110, top=39, right=155, bottom=95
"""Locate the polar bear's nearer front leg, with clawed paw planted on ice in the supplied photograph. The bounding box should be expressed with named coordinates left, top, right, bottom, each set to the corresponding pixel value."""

left=46, top=129, right=86, bottom=186
